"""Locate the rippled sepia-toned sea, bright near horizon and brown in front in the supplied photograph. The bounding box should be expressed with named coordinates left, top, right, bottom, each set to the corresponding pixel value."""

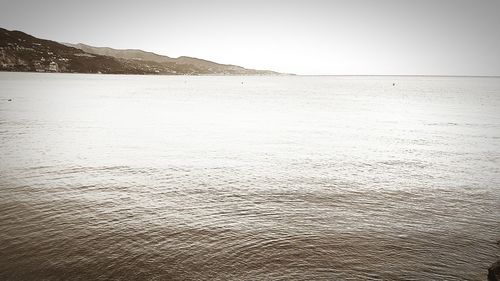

left=0, top=73, right=500, bottom=280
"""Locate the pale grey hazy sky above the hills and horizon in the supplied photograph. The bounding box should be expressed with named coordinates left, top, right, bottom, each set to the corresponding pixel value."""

left=0, top=0, right=500, bottom=75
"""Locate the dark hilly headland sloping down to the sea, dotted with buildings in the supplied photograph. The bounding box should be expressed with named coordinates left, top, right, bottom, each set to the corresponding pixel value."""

left=0, top=28, right=279, bottom=75
